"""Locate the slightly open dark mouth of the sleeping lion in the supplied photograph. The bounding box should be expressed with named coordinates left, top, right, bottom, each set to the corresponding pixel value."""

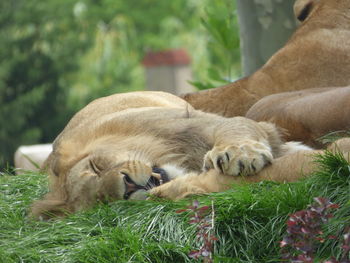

left=123, top=167, right=169, bottom=200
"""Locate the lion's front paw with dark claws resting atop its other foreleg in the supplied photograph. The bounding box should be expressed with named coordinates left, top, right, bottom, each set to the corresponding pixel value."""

left=203, top=142, right=273, bottom=176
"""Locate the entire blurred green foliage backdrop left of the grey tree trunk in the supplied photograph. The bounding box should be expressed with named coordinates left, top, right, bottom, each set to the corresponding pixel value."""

left=0, top=0, right=239, bottom=167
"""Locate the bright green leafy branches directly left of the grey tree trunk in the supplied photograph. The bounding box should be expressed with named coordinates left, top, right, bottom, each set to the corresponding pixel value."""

left=192, top=0, right=241, bottom=89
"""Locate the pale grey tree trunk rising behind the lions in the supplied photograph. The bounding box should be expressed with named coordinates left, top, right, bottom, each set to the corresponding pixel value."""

left=237, top=0, right=296, bottom=76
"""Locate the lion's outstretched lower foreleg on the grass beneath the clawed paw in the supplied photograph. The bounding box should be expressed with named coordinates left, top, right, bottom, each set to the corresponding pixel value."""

left=150, top=138, right=350, bottom=200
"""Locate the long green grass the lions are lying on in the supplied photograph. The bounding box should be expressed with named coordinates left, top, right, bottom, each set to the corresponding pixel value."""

left=0, top=153, right=350, bottom=263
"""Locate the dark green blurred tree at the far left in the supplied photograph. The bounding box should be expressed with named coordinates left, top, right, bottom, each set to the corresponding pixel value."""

left=0, top=0, right=80, bottom=169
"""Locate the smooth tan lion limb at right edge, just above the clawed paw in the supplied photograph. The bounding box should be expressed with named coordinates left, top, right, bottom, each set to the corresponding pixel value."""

left=246, top=87, right=350, bottom=148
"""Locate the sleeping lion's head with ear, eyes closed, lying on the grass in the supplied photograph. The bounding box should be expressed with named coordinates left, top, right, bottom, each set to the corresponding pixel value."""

left=30, top=158, right=169, bottom=220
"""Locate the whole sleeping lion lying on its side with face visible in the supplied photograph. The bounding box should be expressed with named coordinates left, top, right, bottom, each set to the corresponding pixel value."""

left=31, top=92, right=350, bottom=219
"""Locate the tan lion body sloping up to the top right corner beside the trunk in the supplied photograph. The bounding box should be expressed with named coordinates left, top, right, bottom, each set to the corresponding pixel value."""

left=183, top=0, right=350, bottom=117
